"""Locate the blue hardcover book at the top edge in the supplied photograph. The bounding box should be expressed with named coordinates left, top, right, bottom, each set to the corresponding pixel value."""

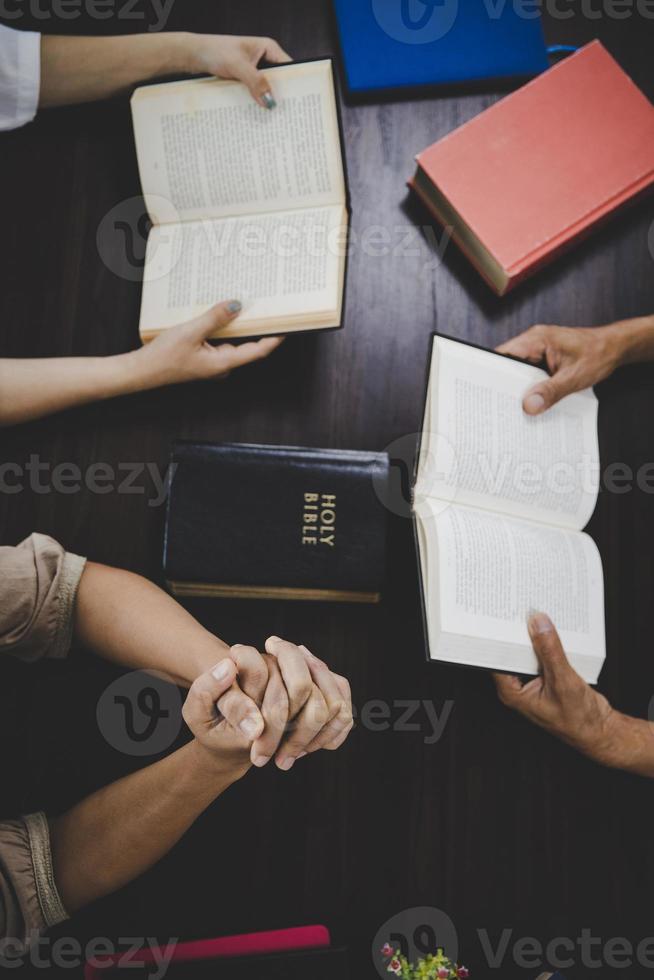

left=334, top=0, right=549, bottom=95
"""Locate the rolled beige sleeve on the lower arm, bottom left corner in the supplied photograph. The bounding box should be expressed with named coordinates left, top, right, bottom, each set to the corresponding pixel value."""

left=0, top=813, right=68, bottom=959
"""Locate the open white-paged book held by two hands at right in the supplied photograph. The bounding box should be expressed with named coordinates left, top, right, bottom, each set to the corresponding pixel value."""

left=414, top=336, right=605, bottom=683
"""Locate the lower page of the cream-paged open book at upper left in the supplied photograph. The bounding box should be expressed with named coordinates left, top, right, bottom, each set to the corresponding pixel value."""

left=140, top=205, right=348, bottom=338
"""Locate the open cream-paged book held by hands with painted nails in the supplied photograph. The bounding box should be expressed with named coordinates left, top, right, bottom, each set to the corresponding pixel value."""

left=132, top=59, right=349, bottom=341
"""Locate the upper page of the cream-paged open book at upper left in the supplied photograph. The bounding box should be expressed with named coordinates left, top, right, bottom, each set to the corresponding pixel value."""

left=132, top=60, right=345, bottom=224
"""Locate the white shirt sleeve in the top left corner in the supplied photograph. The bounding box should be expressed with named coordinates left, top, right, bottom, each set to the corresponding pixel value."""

left=0, top=24, right=41, bottom=130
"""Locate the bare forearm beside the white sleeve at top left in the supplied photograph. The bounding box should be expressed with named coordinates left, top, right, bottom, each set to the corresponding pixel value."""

left=39, top=32, right=191, bottom=107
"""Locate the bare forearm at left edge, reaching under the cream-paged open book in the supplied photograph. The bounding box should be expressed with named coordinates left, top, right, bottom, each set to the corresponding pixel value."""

left=0, top=350, right=157, bottom=426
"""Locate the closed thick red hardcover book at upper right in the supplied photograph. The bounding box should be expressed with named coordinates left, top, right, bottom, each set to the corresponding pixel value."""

left=409, top=41, right=654, bottom=295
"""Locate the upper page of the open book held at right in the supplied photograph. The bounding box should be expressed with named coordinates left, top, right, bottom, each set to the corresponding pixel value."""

left=416, top=337, right=600, bottom=529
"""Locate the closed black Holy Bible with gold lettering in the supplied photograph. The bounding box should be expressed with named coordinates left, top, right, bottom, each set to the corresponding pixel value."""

left=164, top=442, right=389, bottom=602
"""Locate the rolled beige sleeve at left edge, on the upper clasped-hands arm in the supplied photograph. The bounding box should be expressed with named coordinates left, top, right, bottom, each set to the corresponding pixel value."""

left=0, top=534, right=85, bottom=661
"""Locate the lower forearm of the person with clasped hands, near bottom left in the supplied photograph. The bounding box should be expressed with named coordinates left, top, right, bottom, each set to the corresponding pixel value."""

left=50, top=741, right=249, bottom=912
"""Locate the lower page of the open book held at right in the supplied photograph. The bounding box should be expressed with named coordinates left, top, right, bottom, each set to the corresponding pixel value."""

left=421, top=501, right=605, bottom=679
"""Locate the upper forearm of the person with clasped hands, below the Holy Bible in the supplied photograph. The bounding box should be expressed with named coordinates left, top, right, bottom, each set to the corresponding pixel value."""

left=75, top=562, right=229, bottom=687
